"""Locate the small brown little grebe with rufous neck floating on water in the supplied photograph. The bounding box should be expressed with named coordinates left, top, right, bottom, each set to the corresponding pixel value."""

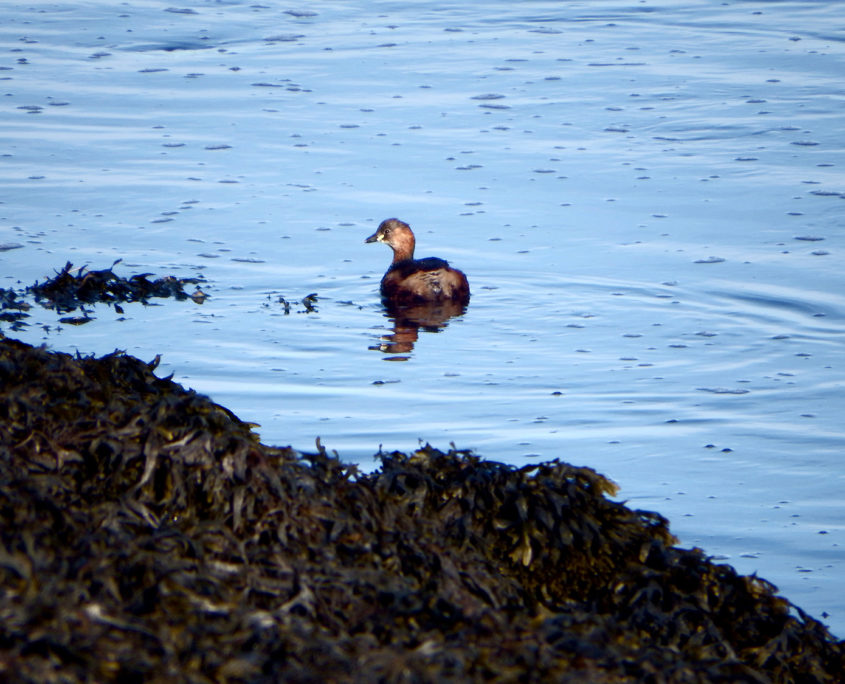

left=364, top=219, right=469, bottom=306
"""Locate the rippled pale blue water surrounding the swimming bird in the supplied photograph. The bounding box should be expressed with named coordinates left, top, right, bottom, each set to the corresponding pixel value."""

left=0, top=0, right=845, bottom=635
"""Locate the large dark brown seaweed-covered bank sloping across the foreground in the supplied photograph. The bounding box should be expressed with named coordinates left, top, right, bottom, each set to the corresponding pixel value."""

left=0, top=338, right=845, bottom=682
